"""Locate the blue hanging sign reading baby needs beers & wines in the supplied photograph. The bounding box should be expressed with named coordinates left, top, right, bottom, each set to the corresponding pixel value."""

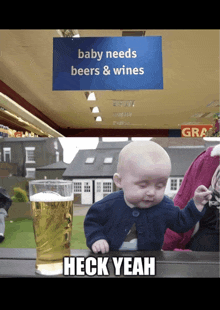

left=53, top=36, right=163, bottom=90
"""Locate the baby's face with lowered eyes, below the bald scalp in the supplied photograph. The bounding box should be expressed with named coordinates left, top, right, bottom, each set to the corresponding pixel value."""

left=121, top=163, right=170, bottom=208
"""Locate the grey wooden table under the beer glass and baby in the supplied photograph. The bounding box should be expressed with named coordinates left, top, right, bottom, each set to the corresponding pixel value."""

left=0, top=248, right=220, bottom=278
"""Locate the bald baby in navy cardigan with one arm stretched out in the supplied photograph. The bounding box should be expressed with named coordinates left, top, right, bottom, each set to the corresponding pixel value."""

left=84, top=141, right=212, bottom=253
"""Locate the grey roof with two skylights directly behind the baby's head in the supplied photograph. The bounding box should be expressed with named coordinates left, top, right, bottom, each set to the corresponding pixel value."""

left=63, top=141, right=211, bottom=178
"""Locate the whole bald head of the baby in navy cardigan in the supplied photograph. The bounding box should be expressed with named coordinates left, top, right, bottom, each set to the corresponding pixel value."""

left=113, top=141, right=171, bottom=208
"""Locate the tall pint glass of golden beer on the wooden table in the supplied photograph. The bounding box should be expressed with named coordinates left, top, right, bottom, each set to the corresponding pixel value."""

left=29, top=180, right=74, bottom=275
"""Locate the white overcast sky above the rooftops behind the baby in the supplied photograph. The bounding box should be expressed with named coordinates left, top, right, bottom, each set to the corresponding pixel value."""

left=59, top=137, right=151, bottom=164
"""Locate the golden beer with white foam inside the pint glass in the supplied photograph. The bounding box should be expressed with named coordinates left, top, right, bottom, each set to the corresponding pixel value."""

left=31, top=193, right=73, bottom=275
